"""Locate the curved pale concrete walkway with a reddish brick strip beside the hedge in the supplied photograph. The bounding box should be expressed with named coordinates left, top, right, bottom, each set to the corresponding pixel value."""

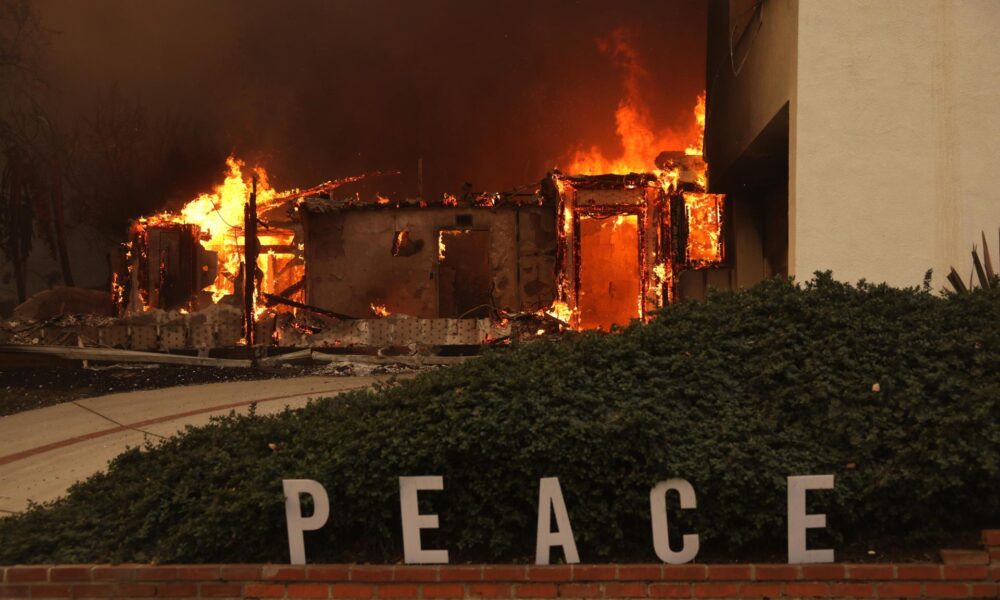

left=0, top=377, right=390, bottom=513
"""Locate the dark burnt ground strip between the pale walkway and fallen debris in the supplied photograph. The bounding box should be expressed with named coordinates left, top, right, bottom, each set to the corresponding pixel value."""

left=0, top=365, right=412, bottom=417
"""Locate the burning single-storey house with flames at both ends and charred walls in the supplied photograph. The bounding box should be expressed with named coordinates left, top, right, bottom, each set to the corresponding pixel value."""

left=94, top=86, right=731, bottom=349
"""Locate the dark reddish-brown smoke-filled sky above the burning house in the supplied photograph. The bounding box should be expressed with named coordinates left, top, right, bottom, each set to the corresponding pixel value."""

left=31, top=0, right=706, bottom=203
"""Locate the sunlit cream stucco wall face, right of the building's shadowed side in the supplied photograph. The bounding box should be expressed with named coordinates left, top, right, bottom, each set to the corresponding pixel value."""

left=789, top=0, right=1000, bottom=287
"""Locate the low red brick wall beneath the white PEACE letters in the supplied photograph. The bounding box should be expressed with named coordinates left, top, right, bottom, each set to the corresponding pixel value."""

left=0, top=530, right=1000, bottom=599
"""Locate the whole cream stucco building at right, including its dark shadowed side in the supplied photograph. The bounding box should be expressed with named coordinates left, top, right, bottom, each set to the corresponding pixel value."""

left=705, top=0, right=1000, bottom=288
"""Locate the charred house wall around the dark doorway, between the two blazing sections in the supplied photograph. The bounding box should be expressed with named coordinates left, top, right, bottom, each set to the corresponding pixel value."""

left=303, top=205, right=556, bottom=318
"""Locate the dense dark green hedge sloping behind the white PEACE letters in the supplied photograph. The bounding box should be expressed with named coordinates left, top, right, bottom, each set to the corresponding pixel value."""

left=0, top=274, right=1000, bottom=563
